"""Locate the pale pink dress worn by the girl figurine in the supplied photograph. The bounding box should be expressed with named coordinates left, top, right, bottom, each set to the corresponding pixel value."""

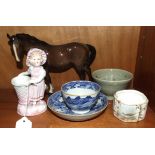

left=28, top=66, right=45, bottom=103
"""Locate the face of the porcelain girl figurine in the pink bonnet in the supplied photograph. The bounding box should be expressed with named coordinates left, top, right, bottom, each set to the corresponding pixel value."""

left=30, top=53, right=42, bottom=67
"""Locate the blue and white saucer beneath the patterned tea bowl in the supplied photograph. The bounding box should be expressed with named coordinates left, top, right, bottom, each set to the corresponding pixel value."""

left=47, top=91, right=108, bottom=121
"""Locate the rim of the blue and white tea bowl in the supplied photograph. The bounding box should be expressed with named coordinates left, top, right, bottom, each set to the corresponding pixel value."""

left=61, top=80, right=101, bottom=96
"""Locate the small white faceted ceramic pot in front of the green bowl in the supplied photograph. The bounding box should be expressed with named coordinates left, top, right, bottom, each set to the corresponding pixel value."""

left=113, top=90, right=148, bottom=122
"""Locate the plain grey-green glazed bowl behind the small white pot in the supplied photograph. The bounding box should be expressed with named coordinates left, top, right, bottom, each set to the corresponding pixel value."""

left=92, top=69, right=133, bottom=100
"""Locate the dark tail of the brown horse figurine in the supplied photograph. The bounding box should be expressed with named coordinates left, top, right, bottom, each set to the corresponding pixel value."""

left=86, top=44, right=96, bottom=66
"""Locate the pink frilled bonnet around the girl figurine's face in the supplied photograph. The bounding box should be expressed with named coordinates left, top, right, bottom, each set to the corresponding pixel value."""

left=26, top=48, right=47, bottom=66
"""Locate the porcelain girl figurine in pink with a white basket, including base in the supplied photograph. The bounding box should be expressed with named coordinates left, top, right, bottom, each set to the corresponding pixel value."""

left=12, top=48, right=47, bottom=116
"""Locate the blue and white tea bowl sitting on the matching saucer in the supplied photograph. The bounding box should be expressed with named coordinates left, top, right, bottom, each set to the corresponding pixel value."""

left=61, top=81, right=101, bottom=114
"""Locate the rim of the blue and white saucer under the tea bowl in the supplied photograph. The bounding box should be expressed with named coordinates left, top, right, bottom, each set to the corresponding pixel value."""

left=47, top=91, right=108, bottom=117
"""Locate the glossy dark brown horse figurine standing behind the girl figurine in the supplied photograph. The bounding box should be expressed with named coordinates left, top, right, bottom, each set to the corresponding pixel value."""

left=7, top=33, right=96, bottom=93
